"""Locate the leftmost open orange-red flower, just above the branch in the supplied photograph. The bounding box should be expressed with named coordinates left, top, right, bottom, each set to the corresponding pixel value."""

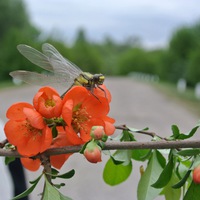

left=4, top=103, right=52, bottom=156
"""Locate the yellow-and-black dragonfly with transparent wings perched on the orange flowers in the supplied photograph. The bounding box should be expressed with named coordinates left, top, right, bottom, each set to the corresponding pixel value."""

left=10, top=43, right=105, bottom=97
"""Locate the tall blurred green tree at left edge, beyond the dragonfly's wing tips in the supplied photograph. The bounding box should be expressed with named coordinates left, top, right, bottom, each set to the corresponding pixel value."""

left=0, top=0, right=39, bottom=80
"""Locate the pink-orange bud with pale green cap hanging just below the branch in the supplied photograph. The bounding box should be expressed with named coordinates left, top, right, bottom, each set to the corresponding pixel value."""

left=84, top=141, right=101, bottom=163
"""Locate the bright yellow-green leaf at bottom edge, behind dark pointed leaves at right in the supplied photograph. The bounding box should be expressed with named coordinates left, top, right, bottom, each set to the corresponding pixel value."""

left=161, top=173, right=181, bottom=200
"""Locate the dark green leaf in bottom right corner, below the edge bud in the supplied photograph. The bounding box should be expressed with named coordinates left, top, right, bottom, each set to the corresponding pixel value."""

left=183, top=181, right=200, bottom=200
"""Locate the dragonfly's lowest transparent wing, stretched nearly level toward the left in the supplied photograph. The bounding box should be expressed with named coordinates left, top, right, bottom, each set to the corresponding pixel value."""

left=10, top=70, right=73, bottom=91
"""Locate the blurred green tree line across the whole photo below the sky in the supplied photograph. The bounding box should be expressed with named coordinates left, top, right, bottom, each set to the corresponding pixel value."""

left=0, top=0, right=200, bottom=86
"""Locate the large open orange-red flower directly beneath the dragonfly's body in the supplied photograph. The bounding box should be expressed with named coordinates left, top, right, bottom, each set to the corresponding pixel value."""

left=62, top=86, right=115, bottom=142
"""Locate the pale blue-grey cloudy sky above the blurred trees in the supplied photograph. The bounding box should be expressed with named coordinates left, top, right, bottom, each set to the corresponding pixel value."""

left=25, top=0, right=200, bottom=47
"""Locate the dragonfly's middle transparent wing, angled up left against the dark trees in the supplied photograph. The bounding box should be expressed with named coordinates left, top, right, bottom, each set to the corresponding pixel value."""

left=17, top=44, right=53, bottom=72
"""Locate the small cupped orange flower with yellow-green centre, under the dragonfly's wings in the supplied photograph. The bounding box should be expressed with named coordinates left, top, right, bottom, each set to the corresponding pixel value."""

left=33, top=87, right=62, bottom=118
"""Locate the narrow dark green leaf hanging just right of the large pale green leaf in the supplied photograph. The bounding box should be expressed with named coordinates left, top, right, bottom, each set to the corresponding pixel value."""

left=152, top=156, right=174, bottom=188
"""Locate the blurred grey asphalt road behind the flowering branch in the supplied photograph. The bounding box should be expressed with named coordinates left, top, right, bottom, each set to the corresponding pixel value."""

left=0, top=78, right=198, bottom=200
